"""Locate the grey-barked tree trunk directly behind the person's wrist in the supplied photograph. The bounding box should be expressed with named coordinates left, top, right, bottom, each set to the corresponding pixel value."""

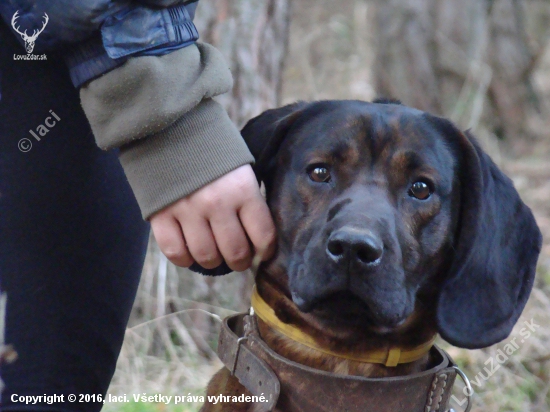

left=196, top=0, right=296, bottom=126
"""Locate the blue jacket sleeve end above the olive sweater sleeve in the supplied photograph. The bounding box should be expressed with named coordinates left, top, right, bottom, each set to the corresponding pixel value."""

left=0, top=0, right=199, bottom=87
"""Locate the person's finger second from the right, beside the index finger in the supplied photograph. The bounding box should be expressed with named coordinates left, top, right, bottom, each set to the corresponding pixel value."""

left=210, top=211, right=252, bottom=272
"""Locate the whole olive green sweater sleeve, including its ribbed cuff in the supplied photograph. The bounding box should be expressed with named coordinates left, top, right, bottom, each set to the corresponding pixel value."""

left=80, top=43, right=254, bottom=219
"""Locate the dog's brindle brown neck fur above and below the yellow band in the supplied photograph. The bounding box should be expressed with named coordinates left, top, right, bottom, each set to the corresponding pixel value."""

left=256, top=273, right=435, bottom=377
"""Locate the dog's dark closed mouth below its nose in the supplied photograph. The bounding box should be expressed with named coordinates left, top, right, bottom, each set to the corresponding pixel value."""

left=302, top=291, right=406, bottom=334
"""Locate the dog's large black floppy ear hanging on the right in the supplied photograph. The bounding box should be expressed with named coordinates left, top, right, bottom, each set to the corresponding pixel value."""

left=430, top=116, right=542, bottom=349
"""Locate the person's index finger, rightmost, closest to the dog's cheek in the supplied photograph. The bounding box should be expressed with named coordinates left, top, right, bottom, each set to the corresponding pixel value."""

left=239, top=197, right=276, bottom=260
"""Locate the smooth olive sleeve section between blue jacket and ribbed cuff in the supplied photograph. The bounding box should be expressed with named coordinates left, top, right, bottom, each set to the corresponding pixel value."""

left=80, top=43, right=233, bottom=150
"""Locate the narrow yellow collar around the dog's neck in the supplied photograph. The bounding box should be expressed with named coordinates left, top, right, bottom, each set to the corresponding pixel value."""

left=251, top=286, right=437, bottom=366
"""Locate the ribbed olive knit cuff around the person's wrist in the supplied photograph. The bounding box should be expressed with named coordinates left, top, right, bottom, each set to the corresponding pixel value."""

left=120, top=99, right=254, bottom=219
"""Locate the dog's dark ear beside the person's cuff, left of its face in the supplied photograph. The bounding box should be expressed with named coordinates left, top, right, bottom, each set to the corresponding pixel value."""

left=241, top=102, right=308, bottom=188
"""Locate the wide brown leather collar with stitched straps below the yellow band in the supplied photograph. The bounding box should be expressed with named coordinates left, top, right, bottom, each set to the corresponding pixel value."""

left=218, top=313, right=469, bottom=412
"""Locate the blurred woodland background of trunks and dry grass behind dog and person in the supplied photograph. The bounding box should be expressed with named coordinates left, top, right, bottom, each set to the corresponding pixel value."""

left=105, top=0, right=550, bottom=412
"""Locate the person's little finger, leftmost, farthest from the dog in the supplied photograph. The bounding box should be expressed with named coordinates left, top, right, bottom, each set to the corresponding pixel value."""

left=151, top=214, right=194, bottom=267
